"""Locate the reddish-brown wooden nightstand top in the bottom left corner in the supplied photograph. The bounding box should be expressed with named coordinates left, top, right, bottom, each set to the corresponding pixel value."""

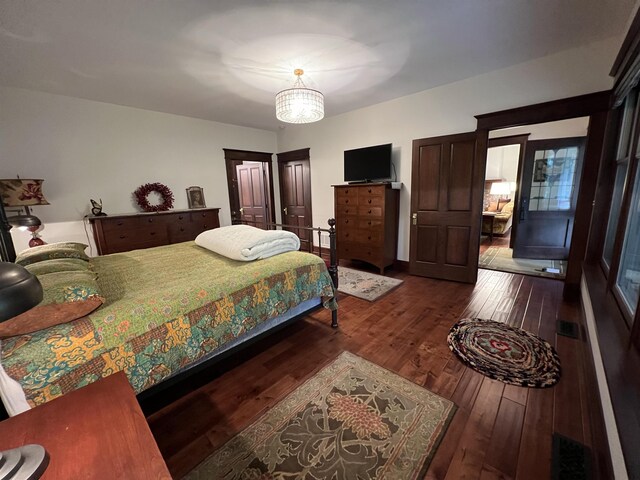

left=0, top=372, right=171, bottom=480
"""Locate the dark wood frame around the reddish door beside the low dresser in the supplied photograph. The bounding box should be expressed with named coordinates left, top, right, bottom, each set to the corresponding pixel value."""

left=222, top=148, right=276, bottom=224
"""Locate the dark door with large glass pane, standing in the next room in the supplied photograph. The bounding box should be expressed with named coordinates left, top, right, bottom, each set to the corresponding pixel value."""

left=513, top=137, right=585, bottom=260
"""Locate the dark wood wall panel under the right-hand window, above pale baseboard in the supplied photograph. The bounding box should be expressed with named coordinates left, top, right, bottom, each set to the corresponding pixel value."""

left=584, top=265, right=640, bottom=478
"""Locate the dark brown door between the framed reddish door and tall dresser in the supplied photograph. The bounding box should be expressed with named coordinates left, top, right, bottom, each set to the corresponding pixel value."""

left=278, top=148, right=313, bottom=251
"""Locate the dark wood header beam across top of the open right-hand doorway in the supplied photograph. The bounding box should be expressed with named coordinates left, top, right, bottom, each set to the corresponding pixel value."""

left=476, top=90, right=612, bottom=130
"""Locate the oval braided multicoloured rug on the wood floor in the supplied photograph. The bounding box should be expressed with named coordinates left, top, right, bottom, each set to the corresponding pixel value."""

left=447, top=318, right=560, bottom=388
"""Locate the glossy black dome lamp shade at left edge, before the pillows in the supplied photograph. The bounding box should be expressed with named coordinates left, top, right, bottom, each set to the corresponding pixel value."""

left=0, top=262, right=42, bottom=322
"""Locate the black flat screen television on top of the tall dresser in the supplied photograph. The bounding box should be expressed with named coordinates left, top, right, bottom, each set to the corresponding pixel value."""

left=344, top=143, right=391, bottom=183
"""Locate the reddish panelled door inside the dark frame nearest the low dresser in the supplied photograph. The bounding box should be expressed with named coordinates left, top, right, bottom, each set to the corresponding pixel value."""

left=236, top=162, right=268, bottom=228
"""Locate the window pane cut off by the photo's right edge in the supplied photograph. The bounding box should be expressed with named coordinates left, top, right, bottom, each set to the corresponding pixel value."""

left=616, top=168, right=640, bottom=317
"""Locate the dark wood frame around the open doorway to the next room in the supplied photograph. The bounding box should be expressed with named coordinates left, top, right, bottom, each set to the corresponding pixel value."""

left=475, top=90, right=613, bottom=300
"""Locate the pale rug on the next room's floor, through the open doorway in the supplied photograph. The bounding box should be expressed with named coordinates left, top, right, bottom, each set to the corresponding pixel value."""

left=478, top=247, right=567, bottom=279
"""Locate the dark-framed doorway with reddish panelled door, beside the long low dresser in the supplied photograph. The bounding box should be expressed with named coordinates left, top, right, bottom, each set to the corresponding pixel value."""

left=223, top=148, right=276, bottom=228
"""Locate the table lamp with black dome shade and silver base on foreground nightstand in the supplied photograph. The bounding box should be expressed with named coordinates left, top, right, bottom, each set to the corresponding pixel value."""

left=0, top=262, right=49, bottom=480
